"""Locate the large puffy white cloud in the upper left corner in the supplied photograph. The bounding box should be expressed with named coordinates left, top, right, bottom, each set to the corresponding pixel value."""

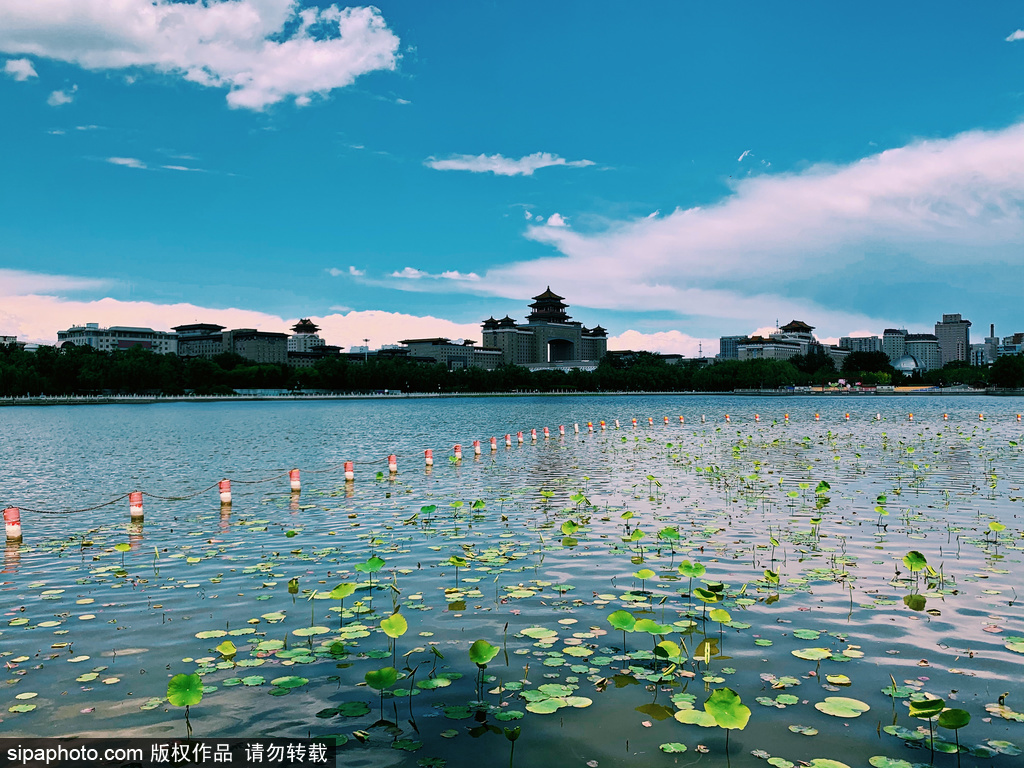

left=0, top=0, right=399, bottom=110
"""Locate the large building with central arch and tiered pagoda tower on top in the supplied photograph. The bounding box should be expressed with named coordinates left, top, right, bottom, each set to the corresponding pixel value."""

left=483, top=287, right=608, bottom=368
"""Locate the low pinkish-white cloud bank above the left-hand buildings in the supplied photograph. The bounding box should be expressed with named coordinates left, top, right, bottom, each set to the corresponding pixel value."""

left=0, top=269, right=480, bottom=347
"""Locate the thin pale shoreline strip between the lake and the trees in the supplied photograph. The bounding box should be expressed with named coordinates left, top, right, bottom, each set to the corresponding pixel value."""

left=0, top=387, right=1024, bottom=407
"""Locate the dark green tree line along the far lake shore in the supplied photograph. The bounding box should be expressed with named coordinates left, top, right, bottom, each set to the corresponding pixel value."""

left=0, top=344, right=1024, bottom=397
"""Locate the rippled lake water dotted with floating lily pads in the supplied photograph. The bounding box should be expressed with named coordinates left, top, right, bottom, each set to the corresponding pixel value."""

left=0, top=396, right=1024, bottom=767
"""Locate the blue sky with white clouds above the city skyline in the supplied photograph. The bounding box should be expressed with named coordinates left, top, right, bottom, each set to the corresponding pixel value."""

left=0, top=0, right=1024, bottom=353
